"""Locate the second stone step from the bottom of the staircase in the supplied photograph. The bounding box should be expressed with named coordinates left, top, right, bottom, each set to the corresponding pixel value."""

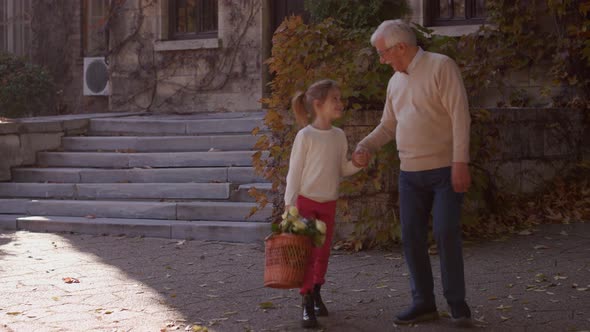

left=0, top=199, right=272, bottom=221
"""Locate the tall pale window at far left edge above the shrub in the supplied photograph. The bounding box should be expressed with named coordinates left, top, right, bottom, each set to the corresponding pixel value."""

left=0, top=0, right=31, bottom=56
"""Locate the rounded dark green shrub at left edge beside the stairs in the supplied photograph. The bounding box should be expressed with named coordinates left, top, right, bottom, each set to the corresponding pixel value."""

left=0, top=53, right=55, bottom=117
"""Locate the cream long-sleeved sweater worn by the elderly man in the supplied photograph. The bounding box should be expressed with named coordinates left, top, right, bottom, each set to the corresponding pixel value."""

left=359, top=49, right=471, bottom=172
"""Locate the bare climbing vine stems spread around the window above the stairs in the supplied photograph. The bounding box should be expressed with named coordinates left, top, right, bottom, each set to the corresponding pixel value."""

left=103, top=0, right=262, bottom=110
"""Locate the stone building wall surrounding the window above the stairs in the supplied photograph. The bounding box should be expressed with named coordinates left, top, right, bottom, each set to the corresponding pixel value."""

left=109, top=0, right=263, bottom=113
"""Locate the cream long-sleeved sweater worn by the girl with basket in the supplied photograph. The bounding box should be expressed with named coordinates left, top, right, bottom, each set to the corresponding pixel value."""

left=285, top=125, right=360, bottom=206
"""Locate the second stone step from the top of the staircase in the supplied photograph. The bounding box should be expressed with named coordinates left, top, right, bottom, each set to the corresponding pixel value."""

left=62, top=134, right=258, bottom=152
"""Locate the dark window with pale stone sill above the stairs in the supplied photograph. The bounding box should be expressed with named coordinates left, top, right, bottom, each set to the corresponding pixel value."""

left=169, top=0, right=217, bottom=39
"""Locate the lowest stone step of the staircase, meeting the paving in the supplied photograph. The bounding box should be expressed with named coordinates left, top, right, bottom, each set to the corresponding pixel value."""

left=0, top=214, right=270, bottom=242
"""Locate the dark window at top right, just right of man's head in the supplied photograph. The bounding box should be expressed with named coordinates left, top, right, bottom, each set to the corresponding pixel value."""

left=428, top=0, right=486, bottom=25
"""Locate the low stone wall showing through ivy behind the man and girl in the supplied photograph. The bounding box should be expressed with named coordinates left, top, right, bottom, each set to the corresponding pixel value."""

left=337, top=108, right=590, bottom=238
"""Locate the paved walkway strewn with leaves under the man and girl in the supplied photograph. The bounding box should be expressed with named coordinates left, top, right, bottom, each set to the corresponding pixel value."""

left=0, top=223, right=590, bottom=332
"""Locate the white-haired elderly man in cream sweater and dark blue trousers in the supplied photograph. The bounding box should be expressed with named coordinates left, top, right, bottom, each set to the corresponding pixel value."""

left=353, top=20, right=471, bottom=326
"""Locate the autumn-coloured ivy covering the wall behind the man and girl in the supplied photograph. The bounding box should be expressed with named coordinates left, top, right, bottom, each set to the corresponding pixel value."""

left=251, top=0, right=590, bottom=250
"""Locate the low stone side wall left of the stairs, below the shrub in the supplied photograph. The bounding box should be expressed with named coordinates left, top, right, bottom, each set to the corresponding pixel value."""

left=0, top=113, right=138, bottom=181
